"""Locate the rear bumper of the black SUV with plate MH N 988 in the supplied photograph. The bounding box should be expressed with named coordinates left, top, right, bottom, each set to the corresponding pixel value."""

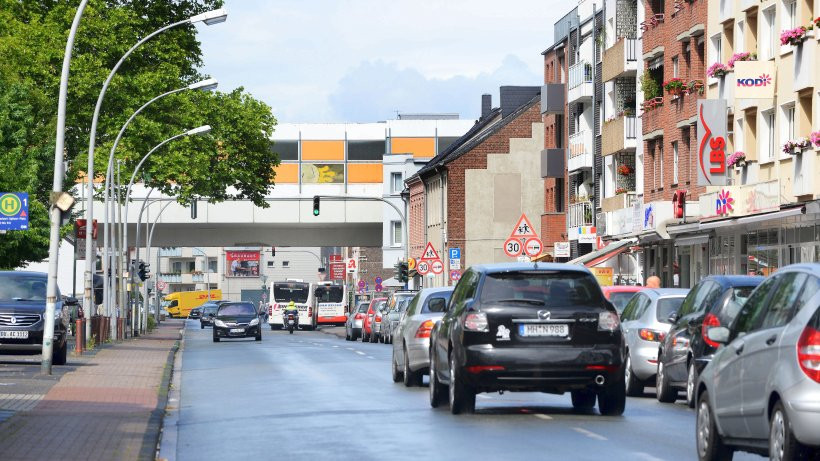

left=462, top=345, right=623, bottom=393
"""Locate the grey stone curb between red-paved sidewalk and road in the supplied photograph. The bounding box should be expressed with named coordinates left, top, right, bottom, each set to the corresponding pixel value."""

left=154, top=323, right=185, bottom=461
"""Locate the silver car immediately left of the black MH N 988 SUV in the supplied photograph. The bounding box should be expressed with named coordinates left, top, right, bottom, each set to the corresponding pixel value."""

left=390, top=287, right=454, bottom=387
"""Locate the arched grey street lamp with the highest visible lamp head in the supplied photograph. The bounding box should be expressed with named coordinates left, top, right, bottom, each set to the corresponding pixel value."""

left=81, top=8, right=228, bottom=342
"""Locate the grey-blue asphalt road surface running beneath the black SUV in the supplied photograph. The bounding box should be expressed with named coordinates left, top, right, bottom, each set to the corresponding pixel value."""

left=177, top=321, right=761, bottom=461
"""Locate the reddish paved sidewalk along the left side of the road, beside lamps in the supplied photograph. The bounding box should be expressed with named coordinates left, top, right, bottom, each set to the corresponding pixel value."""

left=0, top=320, right=184, bottom=461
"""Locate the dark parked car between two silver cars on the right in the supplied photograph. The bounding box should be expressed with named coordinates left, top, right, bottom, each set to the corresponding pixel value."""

left=655, top=275, right=763, bottom=408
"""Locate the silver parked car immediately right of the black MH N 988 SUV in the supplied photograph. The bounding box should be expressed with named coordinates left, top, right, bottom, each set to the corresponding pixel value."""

left=621, top=288, right=689, bottom=396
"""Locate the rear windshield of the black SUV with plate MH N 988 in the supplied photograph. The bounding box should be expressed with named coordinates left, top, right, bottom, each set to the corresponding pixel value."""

left=479, top=271, right=604, bottom=308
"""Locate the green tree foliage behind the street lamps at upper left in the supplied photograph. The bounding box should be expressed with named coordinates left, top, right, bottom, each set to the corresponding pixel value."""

left=0, top=0, right=279, bottom=268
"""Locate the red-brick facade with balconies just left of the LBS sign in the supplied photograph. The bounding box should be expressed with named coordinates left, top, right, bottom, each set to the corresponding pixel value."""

left=642, top=0, right=709, bottom=203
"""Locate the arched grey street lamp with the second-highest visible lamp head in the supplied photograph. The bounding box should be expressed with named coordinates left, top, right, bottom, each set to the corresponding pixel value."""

left=103, top=78, right=219, bottom=329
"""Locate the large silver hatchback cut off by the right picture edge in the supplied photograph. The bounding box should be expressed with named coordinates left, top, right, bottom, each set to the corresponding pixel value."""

left=696, top=263, right=820, bottom=460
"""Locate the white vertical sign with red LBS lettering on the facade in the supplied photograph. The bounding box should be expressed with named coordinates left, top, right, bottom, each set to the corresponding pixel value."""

left=697, top=99, right=728, bottom=186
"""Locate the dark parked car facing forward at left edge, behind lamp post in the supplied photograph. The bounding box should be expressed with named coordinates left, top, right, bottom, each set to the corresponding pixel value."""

left=0, top=271, right=70, bottom=365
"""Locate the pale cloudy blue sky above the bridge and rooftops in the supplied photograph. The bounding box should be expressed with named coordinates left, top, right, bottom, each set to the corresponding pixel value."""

left=197, top=0, right=575, bottom=123
